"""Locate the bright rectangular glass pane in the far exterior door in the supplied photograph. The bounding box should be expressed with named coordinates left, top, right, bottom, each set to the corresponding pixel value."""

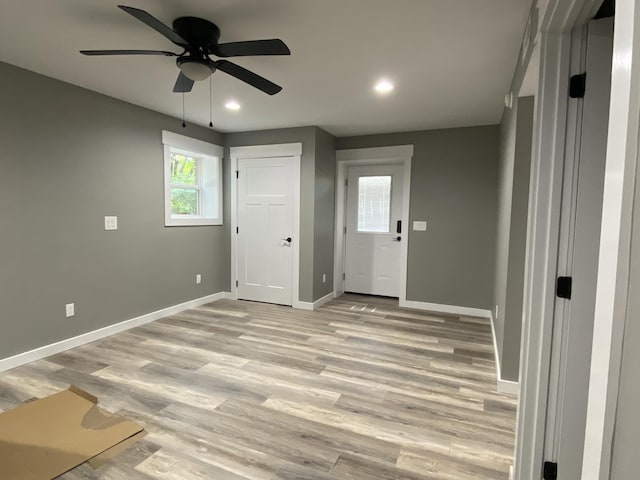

left=358, top=175, right=391, bottom=233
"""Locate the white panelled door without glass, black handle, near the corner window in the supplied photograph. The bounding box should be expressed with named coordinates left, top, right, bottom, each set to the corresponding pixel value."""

left=237, top=157, right=298, bottom=305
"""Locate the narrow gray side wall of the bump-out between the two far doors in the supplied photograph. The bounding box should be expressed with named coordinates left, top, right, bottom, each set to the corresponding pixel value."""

left=313, top=128, right=336, bottom=300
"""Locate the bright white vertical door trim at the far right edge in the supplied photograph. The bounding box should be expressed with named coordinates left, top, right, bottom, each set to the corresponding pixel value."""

left=582, top=0, right=640, bottom=480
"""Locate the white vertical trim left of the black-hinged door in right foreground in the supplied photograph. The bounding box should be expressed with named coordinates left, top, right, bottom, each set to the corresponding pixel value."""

left=515, top=33, right=571, bottom=480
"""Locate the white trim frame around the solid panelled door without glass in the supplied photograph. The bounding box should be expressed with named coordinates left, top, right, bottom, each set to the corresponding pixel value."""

left=229, top=143, right=304, bottom=308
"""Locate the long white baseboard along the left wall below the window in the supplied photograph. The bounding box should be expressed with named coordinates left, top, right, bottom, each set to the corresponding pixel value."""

left=0, top=292, right=230, bottom=372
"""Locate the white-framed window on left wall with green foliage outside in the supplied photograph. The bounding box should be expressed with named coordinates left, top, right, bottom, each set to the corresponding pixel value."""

left=162, top=131, right=223, bottom=226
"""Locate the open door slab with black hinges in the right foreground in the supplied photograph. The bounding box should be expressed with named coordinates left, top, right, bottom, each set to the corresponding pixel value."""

left=551, top=18, right=613, bottom=480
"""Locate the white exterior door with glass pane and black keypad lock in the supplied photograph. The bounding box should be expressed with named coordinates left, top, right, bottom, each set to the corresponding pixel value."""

left=344, top=165, right=406, bottom=297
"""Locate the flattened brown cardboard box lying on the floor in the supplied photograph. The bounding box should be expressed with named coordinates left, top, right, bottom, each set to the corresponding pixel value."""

left=0, top=386, right=144, bottom=480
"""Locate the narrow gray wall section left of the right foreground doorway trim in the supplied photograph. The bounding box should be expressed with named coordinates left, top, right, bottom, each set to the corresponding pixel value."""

left=494, top=97, right=534, bottom=381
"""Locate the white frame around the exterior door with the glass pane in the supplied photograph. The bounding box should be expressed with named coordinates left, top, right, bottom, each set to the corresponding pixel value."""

left=333, top=145, right=413, bottom=305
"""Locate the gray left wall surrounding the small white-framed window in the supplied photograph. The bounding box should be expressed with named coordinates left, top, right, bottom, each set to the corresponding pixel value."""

left=0, top=63, right=230, bottom=358
